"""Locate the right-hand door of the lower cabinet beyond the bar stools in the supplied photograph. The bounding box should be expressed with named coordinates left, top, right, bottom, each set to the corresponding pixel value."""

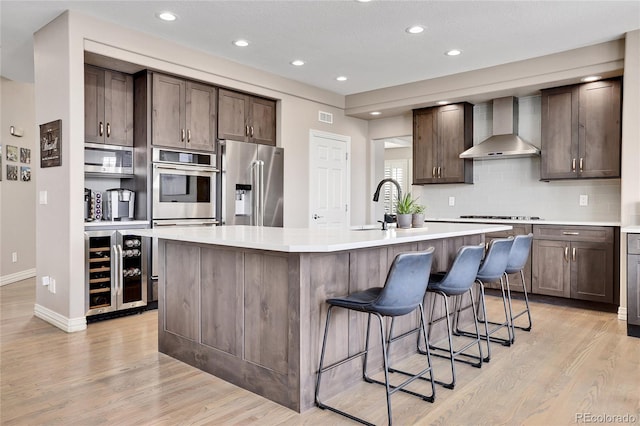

left=571, top=241, right=613, bottom=303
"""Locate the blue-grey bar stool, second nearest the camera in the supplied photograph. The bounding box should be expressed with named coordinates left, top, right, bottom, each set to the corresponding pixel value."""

left=418, top=244, right=484, bottom=389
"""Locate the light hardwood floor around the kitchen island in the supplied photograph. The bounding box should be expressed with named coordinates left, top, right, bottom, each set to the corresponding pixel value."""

left=0, top=279, right=640, bottom=425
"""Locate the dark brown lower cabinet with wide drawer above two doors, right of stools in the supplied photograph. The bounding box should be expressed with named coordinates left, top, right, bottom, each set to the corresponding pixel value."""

left=532, top=225, right=618, bottom=303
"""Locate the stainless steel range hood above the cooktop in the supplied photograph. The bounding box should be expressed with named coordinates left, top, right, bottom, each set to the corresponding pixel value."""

left=460, top=96, right=540, bottom=160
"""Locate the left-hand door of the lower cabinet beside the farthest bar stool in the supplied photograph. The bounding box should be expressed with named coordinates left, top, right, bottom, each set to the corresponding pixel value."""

left=531, top=240, right=571, bottom=297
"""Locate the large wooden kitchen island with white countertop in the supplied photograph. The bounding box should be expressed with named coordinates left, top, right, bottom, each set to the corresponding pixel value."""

left=136, top=223, right=510, bottom=412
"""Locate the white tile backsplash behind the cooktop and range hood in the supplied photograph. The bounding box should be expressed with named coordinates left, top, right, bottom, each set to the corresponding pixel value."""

left=412, top=96, right=620, bottom=222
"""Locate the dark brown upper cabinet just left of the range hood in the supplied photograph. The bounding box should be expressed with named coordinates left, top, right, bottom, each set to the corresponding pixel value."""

left=413, top=102, right=473, bottom=185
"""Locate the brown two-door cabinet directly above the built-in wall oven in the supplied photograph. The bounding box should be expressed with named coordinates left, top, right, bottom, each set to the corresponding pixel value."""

left=152, top=73, right=216, bottom=151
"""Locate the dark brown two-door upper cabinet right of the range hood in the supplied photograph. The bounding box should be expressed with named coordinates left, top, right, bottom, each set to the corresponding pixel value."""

left=540, top=79, right=622, bottom=180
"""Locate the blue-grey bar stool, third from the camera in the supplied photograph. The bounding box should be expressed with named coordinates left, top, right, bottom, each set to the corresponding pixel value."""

left=456, top=237, right=513, bottom=362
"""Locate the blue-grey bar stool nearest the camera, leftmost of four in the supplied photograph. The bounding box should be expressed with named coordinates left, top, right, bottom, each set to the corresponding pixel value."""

left=315, top=247, right=435, bottom=425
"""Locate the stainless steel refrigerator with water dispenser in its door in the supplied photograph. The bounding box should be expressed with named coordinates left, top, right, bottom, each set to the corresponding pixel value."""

left=219, top=140, right=284, bottom=226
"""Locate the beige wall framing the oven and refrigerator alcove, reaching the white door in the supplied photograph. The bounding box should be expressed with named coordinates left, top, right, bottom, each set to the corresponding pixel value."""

left=35, top=11, right=368, bottom=331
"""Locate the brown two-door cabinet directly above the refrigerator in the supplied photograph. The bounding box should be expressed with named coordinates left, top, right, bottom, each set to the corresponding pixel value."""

left=218, top=89, right=276, bottom=146
